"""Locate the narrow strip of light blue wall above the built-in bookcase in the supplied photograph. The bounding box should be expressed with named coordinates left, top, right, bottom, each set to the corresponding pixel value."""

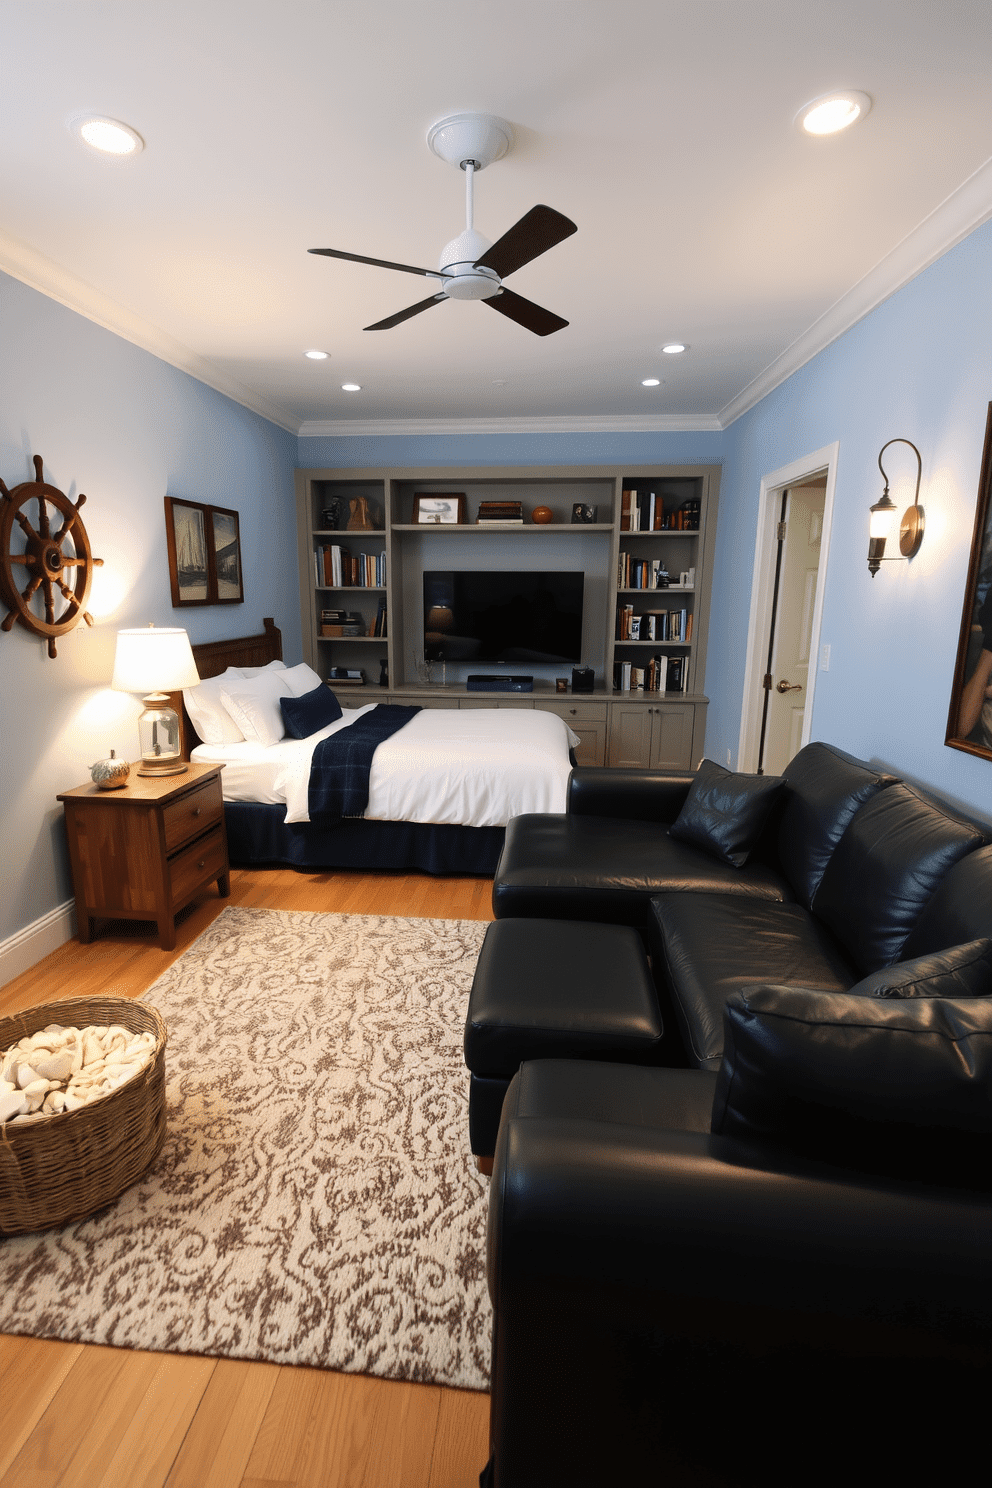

left=299, top=433, right=724, bottom=470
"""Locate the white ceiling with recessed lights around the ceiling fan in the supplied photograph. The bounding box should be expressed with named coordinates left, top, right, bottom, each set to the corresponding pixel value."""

left=0, top=0, right=992, bottom=432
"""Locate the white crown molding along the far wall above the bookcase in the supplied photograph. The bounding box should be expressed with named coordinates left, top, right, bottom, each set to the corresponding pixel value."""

left=299, top=414, right=723, bottom=439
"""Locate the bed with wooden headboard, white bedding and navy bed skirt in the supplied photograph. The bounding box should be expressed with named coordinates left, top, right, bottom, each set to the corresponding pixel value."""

left=175, top=619, right=577, bottom=875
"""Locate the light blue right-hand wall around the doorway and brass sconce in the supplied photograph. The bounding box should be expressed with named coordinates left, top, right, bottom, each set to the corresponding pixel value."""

left=706, top=223, right=992, bottom=820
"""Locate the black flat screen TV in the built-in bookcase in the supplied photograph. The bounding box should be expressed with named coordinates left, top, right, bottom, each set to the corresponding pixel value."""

left=424, top=568, right=584, bottom=664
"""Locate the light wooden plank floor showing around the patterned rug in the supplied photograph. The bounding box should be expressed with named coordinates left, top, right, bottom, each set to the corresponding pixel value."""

left=0, top=869, right=492, bottom=1488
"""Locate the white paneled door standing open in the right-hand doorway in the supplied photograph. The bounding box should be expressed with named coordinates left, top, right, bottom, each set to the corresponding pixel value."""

left=761, top=478, right=827, bottom=775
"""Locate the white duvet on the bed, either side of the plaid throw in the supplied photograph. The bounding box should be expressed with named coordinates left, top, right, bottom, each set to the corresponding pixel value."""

left=192, top=704, right=579, bottom=827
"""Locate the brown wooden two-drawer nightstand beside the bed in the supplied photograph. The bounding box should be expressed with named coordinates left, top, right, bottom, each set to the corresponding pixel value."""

left=58, top=765, right=231, bottom=951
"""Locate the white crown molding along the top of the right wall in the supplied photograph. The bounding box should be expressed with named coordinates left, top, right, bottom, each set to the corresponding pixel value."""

left=720, top=151, right=992, bottom=429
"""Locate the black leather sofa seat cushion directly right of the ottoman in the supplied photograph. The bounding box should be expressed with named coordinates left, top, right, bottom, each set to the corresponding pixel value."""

left=647, top=894, right=858, bottom=1068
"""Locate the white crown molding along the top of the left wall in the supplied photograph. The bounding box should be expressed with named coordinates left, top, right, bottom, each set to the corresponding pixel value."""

left=0, top=234, right=299, bottom=434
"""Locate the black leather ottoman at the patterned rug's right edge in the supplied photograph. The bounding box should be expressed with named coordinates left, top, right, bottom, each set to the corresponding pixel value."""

left=466, top=920, right=663, bottom=1158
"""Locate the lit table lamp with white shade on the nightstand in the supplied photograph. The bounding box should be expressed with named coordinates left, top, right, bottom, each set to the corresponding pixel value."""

left=110, top=625, right=199, bottom=775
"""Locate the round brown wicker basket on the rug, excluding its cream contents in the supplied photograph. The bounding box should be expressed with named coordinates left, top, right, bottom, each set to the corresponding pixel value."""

left=0, top=997, right=167, bottom=1235
